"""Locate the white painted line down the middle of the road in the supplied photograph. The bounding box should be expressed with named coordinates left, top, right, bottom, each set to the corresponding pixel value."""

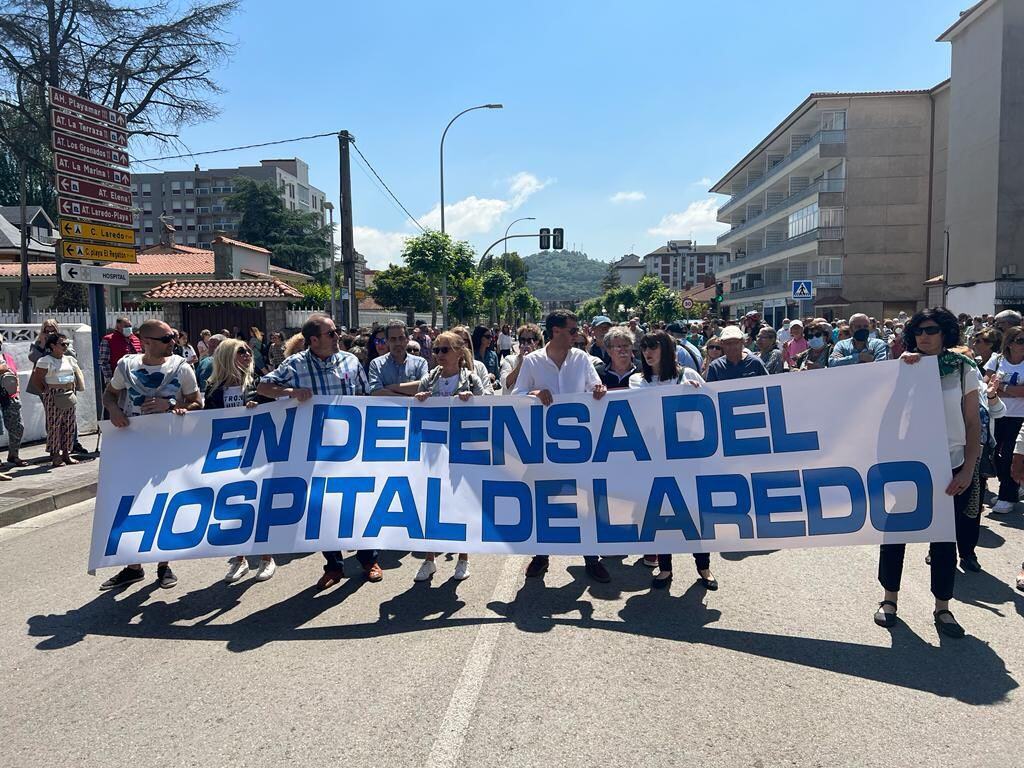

left=426, top=557, right=526, bottom=768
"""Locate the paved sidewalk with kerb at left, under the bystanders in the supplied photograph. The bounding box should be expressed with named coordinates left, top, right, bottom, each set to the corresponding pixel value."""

left=0, top=434, right=99, bottom=527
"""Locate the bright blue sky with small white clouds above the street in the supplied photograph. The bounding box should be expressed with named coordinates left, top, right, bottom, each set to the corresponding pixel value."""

left=133, top=0, right=971, bottom=267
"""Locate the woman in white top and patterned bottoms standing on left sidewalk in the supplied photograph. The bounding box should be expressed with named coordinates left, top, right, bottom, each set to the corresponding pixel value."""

left=30, top=334, right=85, bottom=467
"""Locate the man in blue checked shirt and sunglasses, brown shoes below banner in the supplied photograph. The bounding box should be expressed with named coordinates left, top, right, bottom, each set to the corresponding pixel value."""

left=256, top=314, right=384, bottom=592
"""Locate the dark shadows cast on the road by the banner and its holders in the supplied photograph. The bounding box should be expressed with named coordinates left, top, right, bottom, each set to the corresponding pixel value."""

left=28, top=563, right=1024, bottom=705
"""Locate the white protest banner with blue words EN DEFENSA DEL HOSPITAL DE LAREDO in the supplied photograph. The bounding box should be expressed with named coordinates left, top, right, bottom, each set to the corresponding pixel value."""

left=89, top=358, right=954, bottom=568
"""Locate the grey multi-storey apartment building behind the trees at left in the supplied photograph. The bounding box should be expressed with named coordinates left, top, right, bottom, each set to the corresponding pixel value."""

left=132, top=158, right=327, bottom=250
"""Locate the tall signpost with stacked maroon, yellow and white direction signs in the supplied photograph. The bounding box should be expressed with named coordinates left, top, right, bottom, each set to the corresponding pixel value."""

left=48, top=86, right=136, bottom=417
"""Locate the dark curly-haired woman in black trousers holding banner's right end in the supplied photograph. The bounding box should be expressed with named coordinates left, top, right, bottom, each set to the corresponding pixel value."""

left=874, top=307, right=981, bottom=638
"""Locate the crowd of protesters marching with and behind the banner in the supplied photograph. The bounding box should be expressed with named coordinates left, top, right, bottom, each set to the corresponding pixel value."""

left=22, top=307, right=1024, bottom=637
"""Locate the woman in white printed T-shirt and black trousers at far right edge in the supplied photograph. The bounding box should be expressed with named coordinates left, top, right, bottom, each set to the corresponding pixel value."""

left=985, top=326, right=1024, bottom=514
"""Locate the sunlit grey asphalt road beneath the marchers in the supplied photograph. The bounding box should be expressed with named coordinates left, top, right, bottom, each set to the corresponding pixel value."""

left=0, top=502, right=1024, bottom=768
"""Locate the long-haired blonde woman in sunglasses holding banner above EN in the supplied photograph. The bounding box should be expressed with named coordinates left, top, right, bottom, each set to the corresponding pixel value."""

left=203, top=339, right=278, bottom=584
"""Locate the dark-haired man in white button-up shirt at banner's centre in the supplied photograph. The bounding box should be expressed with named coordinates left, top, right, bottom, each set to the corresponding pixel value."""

left=512, top=309, right=611, bottom=584
